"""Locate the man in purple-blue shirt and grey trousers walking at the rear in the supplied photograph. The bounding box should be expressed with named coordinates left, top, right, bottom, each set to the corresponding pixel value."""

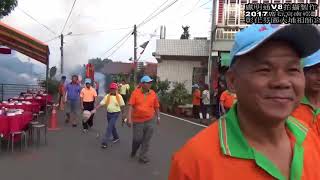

left=65, top=75, right=81, bottom=127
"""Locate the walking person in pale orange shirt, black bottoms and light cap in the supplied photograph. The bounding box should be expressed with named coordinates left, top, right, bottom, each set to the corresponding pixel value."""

left=80, top=78, right=97, bottom=133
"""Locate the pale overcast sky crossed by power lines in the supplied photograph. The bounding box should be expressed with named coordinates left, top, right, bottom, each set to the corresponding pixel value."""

left=2, top=0, right=212, bottom=71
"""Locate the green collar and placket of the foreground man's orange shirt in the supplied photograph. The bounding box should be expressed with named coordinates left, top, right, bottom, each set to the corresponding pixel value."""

left=219, top=104, right=308, bottom=180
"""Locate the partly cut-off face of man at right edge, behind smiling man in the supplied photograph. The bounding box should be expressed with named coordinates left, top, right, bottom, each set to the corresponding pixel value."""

left=305, top=64, right=320, bottom=93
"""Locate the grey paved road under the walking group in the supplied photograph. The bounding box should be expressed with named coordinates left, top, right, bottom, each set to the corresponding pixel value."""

left=0, top=106, right=203, bottom=180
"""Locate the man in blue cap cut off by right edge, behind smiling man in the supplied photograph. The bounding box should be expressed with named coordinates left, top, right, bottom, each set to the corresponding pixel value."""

left=292, top=50, right=320, bottom=136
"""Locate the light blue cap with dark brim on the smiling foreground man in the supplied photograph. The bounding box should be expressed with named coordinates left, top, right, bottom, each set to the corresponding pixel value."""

left=230, top=24, right=320, bottom=65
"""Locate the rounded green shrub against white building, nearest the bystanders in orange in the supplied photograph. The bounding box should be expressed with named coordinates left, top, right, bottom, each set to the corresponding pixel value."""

left=169, top=83, right=190, bottom=106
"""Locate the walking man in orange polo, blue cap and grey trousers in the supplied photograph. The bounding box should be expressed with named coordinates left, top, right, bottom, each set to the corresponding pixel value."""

left=128, top=76, right=160, bottom=163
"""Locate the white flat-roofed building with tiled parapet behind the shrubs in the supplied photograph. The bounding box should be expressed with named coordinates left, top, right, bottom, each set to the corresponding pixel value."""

left=154, top=39, right=210, bottom=93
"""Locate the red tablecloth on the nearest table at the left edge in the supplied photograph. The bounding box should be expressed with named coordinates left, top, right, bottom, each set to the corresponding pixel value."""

left=0, top=111, right=33, bottom=140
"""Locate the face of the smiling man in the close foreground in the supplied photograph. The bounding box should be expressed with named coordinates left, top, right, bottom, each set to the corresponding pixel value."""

left=228, top=41, right=305, bottom=120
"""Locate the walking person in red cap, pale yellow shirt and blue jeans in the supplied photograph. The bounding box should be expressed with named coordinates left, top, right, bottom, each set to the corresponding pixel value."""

left=92, top=83, right=125, bottom=149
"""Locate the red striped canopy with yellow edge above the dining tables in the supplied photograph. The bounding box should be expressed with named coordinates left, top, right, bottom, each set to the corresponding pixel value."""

left=0, top=21, right=50, bottom=87
